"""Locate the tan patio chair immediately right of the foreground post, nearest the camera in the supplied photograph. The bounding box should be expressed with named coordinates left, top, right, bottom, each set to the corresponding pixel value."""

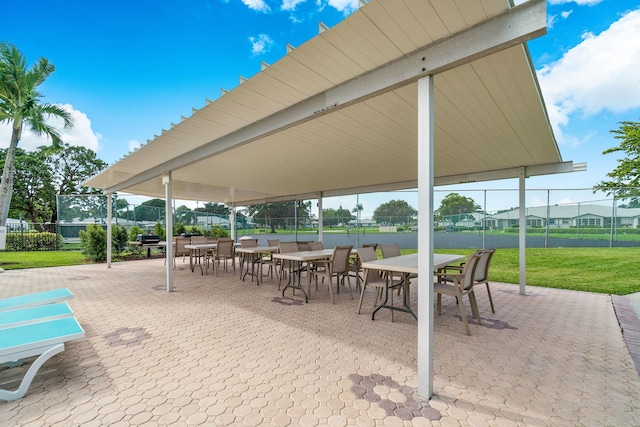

left=433, top=252, right=482, bottom=335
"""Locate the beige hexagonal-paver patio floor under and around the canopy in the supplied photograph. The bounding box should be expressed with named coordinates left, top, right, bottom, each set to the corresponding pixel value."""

left=0, top=259, right=640, bottom=426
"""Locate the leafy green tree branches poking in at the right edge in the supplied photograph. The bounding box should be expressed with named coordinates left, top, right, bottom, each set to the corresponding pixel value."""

left=594, top=121, right=640, bottom=206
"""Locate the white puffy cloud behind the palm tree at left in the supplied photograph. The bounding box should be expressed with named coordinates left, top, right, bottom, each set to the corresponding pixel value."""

left=0, top=104, right=102, bottom=152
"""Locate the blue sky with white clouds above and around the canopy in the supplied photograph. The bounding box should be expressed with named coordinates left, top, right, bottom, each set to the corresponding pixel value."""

left=0, top=0, right=640, bottom=216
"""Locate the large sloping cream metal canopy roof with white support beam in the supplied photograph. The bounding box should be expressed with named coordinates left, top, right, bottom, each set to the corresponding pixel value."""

left=84, top=0, right=584, bottom=205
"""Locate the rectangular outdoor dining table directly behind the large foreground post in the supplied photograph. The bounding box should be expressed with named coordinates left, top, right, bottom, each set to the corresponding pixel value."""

left=362, top=253, right=467, bottom=320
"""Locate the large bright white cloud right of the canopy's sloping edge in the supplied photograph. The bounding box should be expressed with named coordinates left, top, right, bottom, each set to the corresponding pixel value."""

left=538, top=9, right=640, bottom=142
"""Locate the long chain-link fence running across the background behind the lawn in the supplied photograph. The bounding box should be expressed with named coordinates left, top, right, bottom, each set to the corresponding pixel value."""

left=6, top=189, right=640, bottom=251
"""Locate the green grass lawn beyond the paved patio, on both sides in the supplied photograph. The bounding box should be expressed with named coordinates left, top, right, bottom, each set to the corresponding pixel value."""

left=0, top=248, right=640, bottom=295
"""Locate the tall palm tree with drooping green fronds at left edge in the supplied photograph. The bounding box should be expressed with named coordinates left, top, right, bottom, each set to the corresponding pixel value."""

left=0, top=42, right=73, bottom=226
